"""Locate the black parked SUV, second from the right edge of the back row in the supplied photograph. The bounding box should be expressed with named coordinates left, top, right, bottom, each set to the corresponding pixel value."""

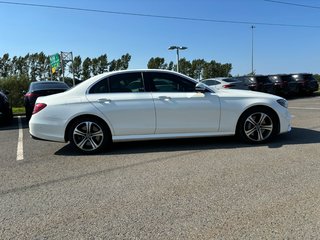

left=269, top=74, right=299, bottom=96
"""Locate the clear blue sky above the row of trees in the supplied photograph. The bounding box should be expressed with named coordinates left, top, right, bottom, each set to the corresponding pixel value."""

left=0, top=0, right=320, bottom=76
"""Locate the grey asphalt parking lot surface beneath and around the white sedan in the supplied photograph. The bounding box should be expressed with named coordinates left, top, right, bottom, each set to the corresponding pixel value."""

left=0, top=96, right=320, bottom=239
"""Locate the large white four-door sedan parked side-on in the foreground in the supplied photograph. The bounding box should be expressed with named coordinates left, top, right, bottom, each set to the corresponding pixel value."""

left=29, top=70, right=291, bottom=153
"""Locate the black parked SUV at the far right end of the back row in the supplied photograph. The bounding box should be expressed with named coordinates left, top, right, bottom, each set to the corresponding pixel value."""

left=292, top=73, right=319, bottom=95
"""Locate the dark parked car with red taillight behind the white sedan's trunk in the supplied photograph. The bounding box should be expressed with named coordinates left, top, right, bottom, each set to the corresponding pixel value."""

left=24, top=81, right=69, bottom=119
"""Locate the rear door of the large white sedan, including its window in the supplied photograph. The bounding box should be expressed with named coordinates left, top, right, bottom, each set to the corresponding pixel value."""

left=87, top=72, right=156, bottom=136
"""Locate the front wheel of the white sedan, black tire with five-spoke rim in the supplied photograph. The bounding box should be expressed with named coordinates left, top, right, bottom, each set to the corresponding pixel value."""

left=237, top=108, right=279, bottom=143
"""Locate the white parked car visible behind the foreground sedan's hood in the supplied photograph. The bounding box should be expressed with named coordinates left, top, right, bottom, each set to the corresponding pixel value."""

left=201, top=77, right=249, bottom=90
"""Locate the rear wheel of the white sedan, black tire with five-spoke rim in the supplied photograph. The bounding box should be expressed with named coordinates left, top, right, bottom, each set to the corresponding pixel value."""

left=68, top=117, right=111, bottom=154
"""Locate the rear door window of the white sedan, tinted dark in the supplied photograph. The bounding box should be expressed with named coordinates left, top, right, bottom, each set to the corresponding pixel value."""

left=109, top=73, right=144, bottom=93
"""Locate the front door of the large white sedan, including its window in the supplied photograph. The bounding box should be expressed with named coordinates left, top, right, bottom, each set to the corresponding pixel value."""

left=144, top=72, right=220, bottom=134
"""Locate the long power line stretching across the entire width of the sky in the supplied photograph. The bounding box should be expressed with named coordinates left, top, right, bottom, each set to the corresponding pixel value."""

left=0, top=1, right=320, bottom=28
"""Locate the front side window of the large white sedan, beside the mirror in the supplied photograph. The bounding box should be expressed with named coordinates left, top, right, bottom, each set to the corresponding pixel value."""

left=147, top=73, right=196, bottom=92
